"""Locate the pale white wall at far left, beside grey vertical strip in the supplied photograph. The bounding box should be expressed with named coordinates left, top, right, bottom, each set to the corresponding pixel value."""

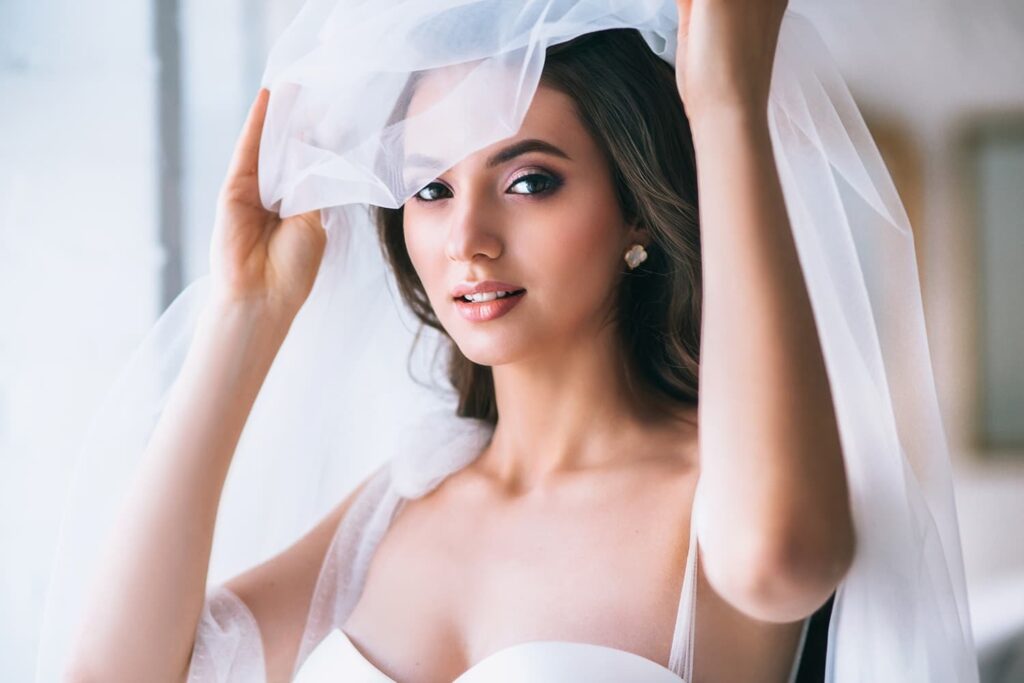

left=0, top=0, right=163, bottom=681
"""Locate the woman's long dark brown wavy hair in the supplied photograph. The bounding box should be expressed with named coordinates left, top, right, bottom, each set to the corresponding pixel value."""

left=372, top=29, right=701, bottom=424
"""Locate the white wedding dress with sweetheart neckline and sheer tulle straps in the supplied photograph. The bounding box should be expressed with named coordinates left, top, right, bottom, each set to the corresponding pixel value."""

left=188, top=468, right=810, bottom=683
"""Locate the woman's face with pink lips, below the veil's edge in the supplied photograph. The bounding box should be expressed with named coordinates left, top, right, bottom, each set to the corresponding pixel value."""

left=404, top=85, right=645, bottom=366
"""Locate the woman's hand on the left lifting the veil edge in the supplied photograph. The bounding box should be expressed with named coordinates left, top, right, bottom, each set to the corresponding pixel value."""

left=210, top=88, right=327, bottom=316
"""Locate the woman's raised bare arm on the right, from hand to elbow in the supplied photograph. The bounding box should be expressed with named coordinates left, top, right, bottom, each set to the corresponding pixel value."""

left=677, top=0, right=855, bottom=622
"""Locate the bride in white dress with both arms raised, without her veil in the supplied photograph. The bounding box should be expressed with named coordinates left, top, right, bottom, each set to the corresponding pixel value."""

left=59, top=0, right=958, bottom=683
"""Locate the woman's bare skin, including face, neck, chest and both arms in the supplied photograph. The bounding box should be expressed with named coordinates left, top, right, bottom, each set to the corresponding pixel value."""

left=69, top=0, right=855, bottom=681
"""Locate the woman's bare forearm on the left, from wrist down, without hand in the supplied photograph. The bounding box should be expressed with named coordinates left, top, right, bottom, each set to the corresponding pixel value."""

left=71, top=302, right=290, bottom=681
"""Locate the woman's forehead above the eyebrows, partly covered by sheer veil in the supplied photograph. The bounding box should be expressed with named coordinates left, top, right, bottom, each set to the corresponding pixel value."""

left=402, top=65, right=589, bottom=176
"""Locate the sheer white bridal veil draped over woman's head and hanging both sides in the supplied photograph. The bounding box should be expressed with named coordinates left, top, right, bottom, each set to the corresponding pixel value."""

left=37, top=0, right=978, bottom=683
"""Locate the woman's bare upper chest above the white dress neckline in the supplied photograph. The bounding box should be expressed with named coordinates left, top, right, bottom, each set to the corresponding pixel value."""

left=346, top=473, right=692, bottom=681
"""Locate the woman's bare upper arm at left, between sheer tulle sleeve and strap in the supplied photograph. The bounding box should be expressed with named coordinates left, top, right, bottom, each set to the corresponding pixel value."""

left=224, top=466, right=380, bottom=682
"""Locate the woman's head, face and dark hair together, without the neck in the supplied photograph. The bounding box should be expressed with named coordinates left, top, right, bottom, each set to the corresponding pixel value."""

left=372, top=29, right=702, bottom=424
